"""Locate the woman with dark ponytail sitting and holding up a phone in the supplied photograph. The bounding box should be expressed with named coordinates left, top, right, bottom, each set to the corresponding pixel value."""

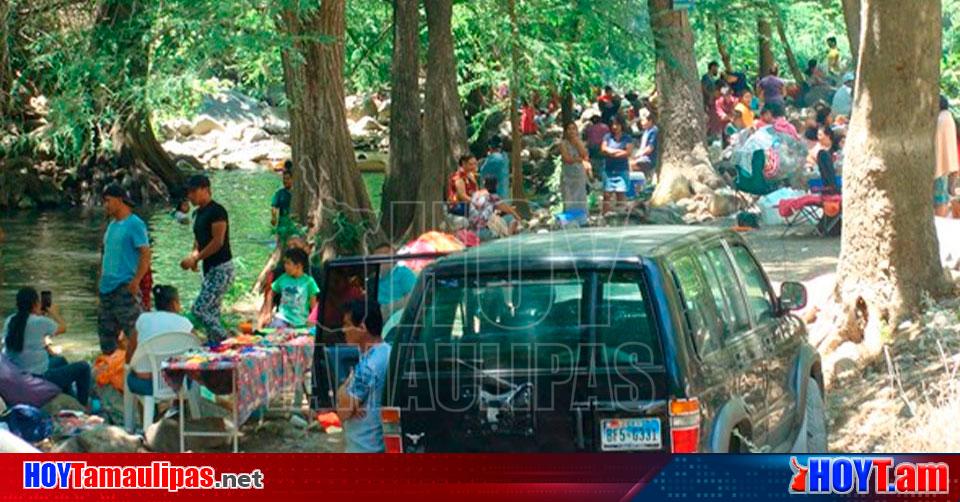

left=3, top=288, right=91, bottom=406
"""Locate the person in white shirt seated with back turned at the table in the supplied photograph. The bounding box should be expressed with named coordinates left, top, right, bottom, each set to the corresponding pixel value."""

left=127, top=285, right=193, bottom=396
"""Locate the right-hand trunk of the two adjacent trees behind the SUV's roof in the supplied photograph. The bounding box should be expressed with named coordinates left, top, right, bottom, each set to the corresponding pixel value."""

left=412, top=0, right=468, bottom=235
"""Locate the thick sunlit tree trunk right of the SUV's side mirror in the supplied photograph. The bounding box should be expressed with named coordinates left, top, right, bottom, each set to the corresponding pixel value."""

left=835, top=0, right=947, bottom=354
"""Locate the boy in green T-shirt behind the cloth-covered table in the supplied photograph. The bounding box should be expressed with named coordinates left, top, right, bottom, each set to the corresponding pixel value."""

left=267, top=248, right=320, bottom=328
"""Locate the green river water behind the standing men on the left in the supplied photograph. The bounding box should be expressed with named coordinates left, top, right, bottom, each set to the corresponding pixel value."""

left=0, top=171, right=383, bottom=357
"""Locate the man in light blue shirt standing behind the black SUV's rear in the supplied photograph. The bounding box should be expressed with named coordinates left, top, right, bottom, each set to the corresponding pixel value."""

left=337, top=299, right=390, bottom=453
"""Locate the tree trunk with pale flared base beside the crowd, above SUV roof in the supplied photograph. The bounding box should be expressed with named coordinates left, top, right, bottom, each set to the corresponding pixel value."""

left=648, top=0, right=724, bottom=206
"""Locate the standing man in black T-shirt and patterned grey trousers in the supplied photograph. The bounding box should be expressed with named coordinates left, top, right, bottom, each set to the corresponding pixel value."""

left=180, top=174, right=235, bottom=342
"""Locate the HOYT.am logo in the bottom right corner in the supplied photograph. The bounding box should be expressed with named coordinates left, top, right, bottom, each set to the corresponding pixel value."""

left=790, top=457, right=950, bottom=495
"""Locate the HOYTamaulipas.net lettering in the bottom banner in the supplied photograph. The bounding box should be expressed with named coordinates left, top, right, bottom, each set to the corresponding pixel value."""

left=23, top=461, right=263, bottom=492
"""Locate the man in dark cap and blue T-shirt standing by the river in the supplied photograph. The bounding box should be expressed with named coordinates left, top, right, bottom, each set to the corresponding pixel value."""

left=97, top=184, right=150, bottom=355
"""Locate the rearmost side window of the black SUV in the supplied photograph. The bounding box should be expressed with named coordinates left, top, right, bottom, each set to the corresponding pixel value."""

left=667, top=254, right=723, bottom=355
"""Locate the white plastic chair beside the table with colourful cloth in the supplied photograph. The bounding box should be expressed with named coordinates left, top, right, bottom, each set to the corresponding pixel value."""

left=123, top=332, right=200, bottom=433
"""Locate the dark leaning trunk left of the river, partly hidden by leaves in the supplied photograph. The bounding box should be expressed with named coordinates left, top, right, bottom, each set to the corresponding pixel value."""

left=97, top=0, right=185, bottom=197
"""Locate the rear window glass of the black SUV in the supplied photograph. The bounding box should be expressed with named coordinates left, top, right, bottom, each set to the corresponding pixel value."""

left=413, top=272, right=662, bottom=370
